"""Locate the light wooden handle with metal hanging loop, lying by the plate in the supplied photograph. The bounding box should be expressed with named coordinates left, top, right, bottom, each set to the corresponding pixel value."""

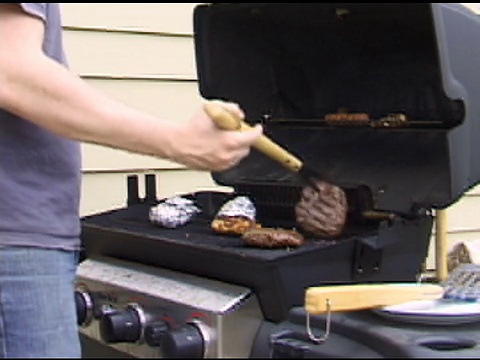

left=305, top=283, right=443, bottom=315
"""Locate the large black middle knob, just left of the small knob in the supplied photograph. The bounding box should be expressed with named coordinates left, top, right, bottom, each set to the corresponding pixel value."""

left=99, top=308, right=143, bottom=344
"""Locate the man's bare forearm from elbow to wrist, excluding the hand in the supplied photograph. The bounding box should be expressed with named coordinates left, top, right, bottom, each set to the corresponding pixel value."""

left=0, top=50, right=178, bottom=157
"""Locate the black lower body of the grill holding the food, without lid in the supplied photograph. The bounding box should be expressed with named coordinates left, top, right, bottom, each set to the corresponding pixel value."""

left=79, top=179, right=432, bottom=321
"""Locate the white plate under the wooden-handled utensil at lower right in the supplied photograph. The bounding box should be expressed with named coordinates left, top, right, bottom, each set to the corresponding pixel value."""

left=373, top=299, right=480, bottom=325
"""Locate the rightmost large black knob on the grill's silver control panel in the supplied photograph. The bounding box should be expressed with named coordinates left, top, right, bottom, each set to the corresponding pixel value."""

left=160, top=325, right=205, bottom=359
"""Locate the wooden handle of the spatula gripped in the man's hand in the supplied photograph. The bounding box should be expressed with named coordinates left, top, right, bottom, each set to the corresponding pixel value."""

left=204, top=101, right=303, bottom=172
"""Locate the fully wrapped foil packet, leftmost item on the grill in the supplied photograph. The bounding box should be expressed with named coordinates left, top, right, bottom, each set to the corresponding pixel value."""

left=149, top=196, right=201, bottom=229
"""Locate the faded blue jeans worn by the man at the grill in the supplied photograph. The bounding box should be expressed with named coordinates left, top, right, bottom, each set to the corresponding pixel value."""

left=0, top=247, right=81, bottom=358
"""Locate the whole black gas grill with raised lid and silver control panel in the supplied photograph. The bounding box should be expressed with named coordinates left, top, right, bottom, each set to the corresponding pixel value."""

left=80, top=3, right=480, bottom=357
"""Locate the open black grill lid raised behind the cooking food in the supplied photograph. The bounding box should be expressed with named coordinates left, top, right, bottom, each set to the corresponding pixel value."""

left=194, top=3, right=480, bottom=213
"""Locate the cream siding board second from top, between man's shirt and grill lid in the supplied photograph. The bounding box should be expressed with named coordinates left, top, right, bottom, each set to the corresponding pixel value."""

left=65, top=30, right=196, bottom=80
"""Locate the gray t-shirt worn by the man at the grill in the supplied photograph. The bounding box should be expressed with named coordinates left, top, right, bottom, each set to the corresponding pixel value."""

left=0, top=3, right=81, bottom=250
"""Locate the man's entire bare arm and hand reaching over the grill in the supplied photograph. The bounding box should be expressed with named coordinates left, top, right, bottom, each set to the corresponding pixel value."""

left=0, top=3, right=261, bottom=170
